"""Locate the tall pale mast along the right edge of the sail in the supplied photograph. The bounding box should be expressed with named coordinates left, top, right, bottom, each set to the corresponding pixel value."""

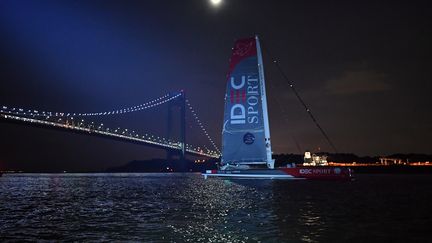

left=255, top=35, right=274, bottom=169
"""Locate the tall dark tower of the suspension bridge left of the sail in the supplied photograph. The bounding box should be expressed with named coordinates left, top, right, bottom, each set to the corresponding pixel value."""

left=166, top=90, right=186, bottom=162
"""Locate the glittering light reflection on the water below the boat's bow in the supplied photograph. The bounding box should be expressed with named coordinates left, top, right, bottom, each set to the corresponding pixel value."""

left=166, top=175, right=264, bottom=242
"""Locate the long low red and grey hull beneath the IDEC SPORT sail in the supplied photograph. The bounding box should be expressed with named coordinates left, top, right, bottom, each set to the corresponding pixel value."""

left=203, top=166, right=354, bottom=180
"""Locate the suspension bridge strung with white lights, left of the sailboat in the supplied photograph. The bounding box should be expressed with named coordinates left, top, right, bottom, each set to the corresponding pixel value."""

left=0, top=91, right=221, bottom=160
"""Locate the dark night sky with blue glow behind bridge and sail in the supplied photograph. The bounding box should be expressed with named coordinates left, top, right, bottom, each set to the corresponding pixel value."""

left=0, top=0, right=432, bottom=171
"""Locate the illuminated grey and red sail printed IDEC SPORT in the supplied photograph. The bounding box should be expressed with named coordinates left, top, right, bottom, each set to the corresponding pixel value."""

left=221, top=37, right=274, bottom=168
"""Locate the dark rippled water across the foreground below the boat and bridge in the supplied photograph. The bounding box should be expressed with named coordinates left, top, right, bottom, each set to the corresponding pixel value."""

left=0, top=174, right=432, bottom=242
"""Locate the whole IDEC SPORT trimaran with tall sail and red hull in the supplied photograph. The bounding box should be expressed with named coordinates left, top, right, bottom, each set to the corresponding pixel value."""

left=203, top=36, right=353, bottom=179
